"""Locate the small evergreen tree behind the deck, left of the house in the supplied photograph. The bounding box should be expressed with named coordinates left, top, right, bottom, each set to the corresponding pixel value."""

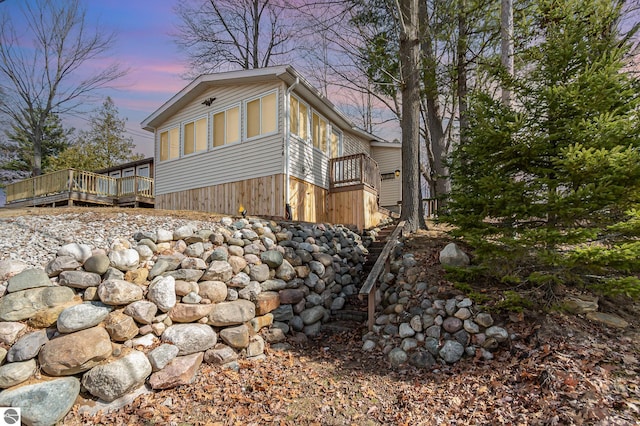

left=51, top=97, right=143, bottom=171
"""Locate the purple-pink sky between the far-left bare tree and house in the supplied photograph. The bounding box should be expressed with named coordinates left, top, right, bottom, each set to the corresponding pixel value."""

left=0, top=0, right=188, bottom=156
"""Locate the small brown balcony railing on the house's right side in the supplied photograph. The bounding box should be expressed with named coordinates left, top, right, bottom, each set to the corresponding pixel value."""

left=329, top=154, right=381, bottom=192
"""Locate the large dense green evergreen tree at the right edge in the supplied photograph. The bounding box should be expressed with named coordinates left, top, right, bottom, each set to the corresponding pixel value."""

left=445, top=0, right=640, bottom=295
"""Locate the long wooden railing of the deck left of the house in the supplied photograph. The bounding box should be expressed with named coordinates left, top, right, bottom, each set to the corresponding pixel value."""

left=5, top=169, right=153, bottom=204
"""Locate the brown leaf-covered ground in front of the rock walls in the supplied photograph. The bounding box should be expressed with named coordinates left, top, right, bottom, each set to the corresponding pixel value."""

left=0, top=208, right=640, bottom=426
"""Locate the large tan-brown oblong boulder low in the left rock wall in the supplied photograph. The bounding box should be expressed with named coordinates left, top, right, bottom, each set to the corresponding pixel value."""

left=38, top=327, right=112, bottom=376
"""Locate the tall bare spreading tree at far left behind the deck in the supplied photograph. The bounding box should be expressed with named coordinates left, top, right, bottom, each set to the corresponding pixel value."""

left=0, top=0, right=125, bottom=176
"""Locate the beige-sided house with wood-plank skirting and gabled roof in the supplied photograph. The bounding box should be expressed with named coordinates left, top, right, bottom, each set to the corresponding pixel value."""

left=142, top=66, right=401, bottom=229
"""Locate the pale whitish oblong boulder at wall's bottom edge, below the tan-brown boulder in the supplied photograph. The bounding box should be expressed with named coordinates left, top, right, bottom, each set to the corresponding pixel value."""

left=82, top=350, right=151, bottom=402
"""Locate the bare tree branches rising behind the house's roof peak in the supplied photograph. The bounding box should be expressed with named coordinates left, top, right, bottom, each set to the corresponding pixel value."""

left=175, top=0, right=295, bottom=74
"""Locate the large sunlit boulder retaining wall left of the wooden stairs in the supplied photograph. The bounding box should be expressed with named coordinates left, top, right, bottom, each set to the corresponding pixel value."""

left=0, top=218, right=367, bottom=424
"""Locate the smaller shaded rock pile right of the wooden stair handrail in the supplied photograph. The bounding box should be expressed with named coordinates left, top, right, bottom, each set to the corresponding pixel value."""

left=362, top=246, right=510, bottom=368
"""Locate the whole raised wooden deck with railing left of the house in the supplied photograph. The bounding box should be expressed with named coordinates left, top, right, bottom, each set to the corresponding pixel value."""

left=5, top=169, right=155, bottom=208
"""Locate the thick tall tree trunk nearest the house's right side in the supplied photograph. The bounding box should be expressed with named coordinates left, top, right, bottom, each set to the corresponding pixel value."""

left=399, top=0, right=426, bottom=232
